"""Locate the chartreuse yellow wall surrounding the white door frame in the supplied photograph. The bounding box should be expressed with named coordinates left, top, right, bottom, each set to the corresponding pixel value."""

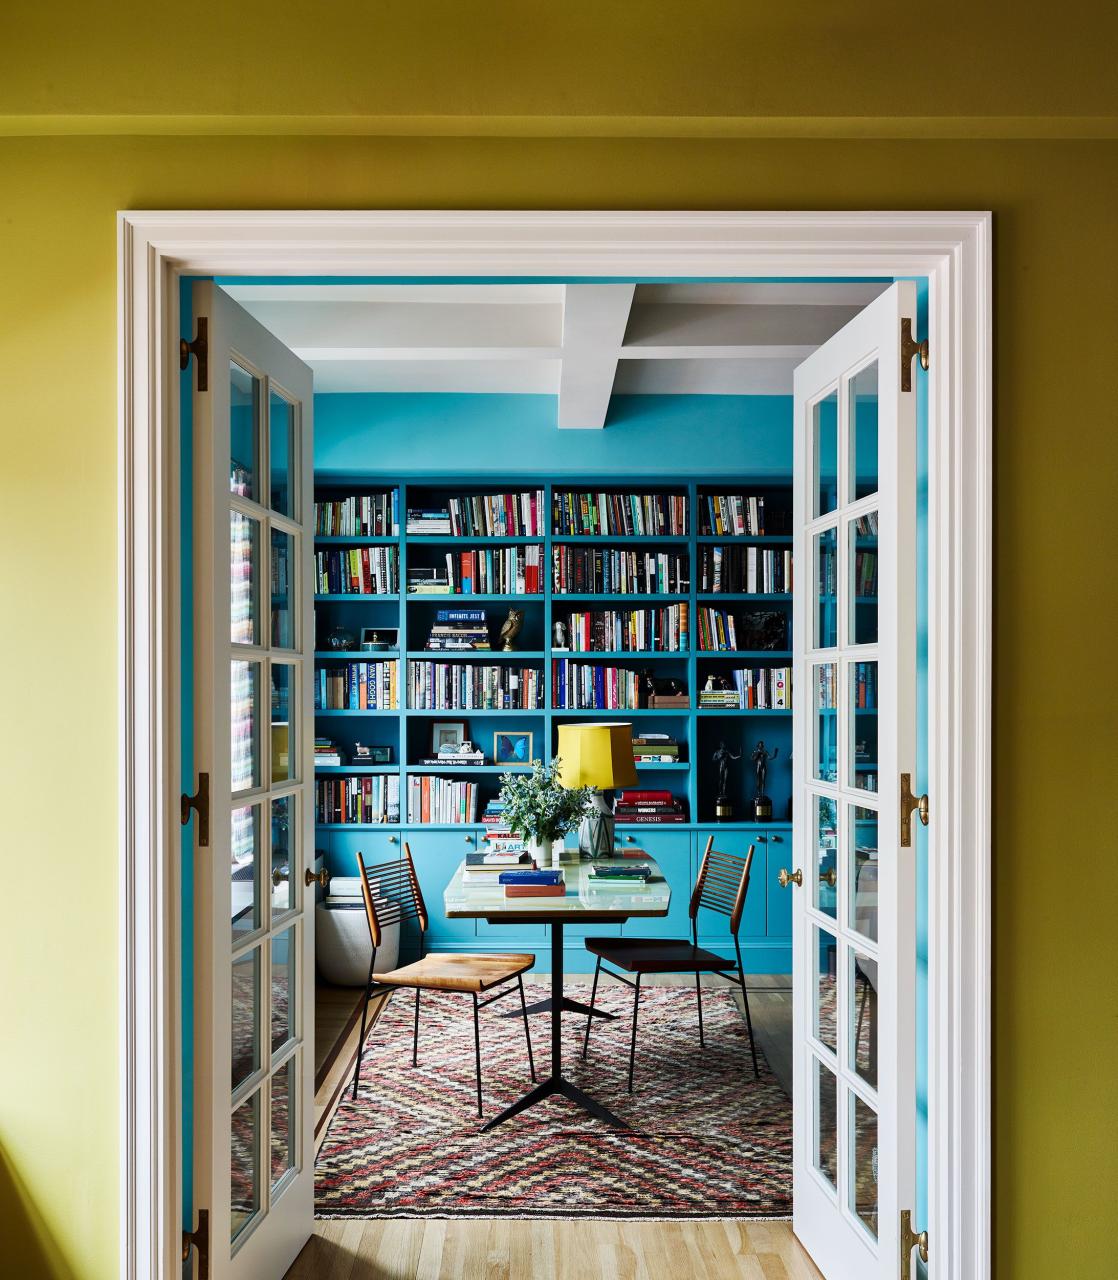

left=0, top=10, right=1118, bottom=1280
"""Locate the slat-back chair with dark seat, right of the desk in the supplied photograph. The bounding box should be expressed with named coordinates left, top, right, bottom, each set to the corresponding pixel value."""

left=583, top=836, right=761, bottom=1093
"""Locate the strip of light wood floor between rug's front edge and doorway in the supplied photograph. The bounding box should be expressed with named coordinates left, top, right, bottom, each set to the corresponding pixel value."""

left=287, top=1217, right=822, bottom=1280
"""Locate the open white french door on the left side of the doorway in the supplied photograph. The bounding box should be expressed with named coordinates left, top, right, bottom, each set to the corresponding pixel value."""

left=193, top=283, right=314, bottom=1280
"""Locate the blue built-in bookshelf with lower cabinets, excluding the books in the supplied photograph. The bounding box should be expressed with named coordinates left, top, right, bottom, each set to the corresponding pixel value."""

left=315, top=475, right=791, bottom=973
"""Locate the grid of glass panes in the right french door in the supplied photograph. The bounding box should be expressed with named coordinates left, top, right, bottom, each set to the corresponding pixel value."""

left=804, top=360, right=879, bottom=1240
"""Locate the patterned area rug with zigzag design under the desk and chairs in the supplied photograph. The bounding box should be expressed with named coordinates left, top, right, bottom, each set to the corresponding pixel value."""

left=315, top=982, right=791, bottom=1219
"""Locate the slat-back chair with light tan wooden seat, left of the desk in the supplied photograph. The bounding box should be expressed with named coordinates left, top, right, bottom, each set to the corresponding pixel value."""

left=353, top=842, right=535, bottom=1116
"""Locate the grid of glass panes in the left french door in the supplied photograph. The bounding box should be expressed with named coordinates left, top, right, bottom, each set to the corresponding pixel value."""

left=228, top=360, right=307, bottom=1242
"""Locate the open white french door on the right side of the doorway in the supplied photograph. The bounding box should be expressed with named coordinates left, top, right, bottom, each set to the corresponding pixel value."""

left=786, top=284, right=917, bottom=1280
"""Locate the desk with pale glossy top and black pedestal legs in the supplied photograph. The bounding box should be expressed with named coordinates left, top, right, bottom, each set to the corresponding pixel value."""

left=443, top=854, right=671, bottom=1133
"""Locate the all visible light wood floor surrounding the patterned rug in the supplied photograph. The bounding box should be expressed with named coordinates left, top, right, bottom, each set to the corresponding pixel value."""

left=300, top=972, right=822, bottom=1280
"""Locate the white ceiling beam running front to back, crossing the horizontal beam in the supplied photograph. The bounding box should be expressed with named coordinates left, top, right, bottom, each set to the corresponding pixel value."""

left=558, top=284, right=634, bottom=430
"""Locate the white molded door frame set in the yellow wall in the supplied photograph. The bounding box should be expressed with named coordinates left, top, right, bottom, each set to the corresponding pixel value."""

left=118, top=211, right=992, bottom=1280
